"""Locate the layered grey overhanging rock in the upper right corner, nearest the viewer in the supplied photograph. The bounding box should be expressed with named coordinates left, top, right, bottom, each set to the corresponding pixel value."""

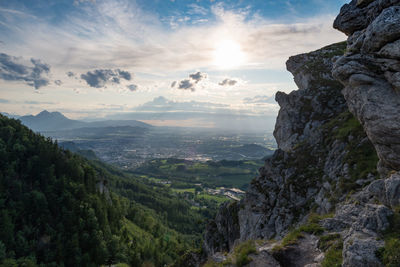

left=333, top=0, right=400, bottom=175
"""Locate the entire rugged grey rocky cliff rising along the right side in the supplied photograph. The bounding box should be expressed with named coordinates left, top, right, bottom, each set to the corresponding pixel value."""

left=204, top=0, right=400, bottom=266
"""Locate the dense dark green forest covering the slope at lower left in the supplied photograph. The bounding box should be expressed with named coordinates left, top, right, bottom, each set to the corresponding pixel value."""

left=0, top=115, right=212, bottom=266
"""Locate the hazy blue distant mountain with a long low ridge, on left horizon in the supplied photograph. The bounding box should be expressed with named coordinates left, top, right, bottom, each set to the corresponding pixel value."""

left=19, top=110, right=151, bottom=132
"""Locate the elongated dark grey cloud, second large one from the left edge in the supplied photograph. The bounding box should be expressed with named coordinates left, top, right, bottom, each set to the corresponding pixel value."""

left=81, top=69, right=132, bottom=88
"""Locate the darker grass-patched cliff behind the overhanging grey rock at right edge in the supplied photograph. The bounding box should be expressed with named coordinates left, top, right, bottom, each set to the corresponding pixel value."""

left=205, top=43, right=376, bottom=254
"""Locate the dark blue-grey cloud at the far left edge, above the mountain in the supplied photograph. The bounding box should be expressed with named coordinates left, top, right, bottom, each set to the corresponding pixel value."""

left=0, top=53, right=50, bottom=89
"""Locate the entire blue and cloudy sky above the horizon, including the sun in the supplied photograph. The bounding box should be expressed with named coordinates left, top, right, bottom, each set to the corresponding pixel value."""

left=0, top=0, right=346, bottom=126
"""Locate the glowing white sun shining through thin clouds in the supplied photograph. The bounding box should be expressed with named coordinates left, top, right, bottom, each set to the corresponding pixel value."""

left=214, top=40, right=245, bottom=69
